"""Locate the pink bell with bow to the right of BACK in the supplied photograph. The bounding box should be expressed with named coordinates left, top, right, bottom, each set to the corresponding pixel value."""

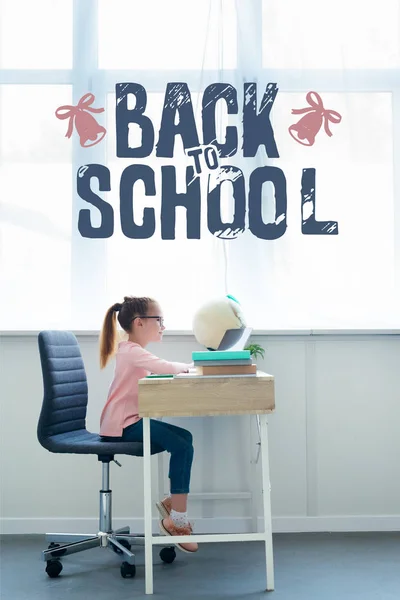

left=288, top=92, right=342, bottom=146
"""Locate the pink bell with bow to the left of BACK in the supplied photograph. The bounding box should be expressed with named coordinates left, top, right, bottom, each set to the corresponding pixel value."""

left=55, top=94, right=107, bottom=148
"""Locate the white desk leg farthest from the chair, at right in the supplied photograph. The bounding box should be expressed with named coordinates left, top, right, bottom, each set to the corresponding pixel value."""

left=260, top=415, right=274, bottom=592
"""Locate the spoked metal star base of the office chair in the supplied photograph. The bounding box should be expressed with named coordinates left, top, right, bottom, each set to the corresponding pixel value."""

left=42, top=527, right=171, bottom=565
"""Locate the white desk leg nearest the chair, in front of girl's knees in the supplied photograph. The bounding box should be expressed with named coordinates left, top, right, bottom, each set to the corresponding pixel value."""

left=143, top=417, right=153, bottom=594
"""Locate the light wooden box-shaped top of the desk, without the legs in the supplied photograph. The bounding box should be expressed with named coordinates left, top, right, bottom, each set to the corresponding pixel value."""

left=139, top=371, right=275, bottom=417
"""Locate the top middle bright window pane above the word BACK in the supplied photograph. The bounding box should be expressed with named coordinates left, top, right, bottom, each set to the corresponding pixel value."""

left=98, top=0, right=237, bottom=72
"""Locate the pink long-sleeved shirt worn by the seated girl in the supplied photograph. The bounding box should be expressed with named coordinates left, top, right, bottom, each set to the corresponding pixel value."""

left=100, top=342, right=191, bottom=437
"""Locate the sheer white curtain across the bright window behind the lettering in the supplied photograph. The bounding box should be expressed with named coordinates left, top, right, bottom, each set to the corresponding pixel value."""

left=0, top=0, right=400, bottom=330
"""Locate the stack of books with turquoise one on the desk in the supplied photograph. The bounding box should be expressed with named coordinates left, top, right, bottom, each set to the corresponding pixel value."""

left=192, top=350, right=257, bottom=376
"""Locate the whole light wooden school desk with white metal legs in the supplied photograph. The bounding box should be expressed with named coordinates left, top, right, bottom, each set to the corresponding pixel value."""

left=139, top=371, right=275, bottom=594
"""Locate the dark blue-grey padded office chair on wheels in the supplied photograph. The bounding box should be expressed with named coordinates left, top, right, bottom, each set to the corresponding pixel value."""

left=37, top=331, right=176, bottom=577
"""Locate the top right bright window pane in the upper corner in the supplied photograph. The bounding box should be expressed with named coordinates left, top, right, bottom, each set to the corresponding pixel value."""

left=262, top=0, right=400, bottom=69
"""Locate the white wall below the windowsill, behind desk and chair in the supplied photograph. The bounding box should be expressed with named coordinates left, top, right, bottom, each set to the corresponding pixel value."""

left=0, top=335, right=400, bottom=533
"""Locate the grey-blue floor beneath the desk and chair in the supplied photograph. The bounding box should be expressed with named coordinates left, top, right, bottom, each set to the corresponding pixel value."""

left=0, top=533, right=400, bottom=600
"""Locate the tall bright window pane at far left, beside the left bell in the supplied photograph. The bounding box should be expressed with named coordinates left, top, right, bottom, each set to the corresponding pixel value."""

left=0, top=84, right=73, bottom=330
